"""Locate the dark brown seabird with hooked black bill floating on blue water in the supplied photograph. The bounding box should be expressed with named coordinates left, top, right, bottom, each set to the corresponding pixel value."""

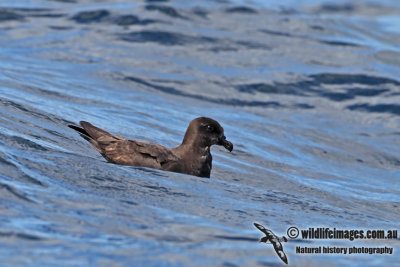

left=68, top=117, right=233, bottom=178
